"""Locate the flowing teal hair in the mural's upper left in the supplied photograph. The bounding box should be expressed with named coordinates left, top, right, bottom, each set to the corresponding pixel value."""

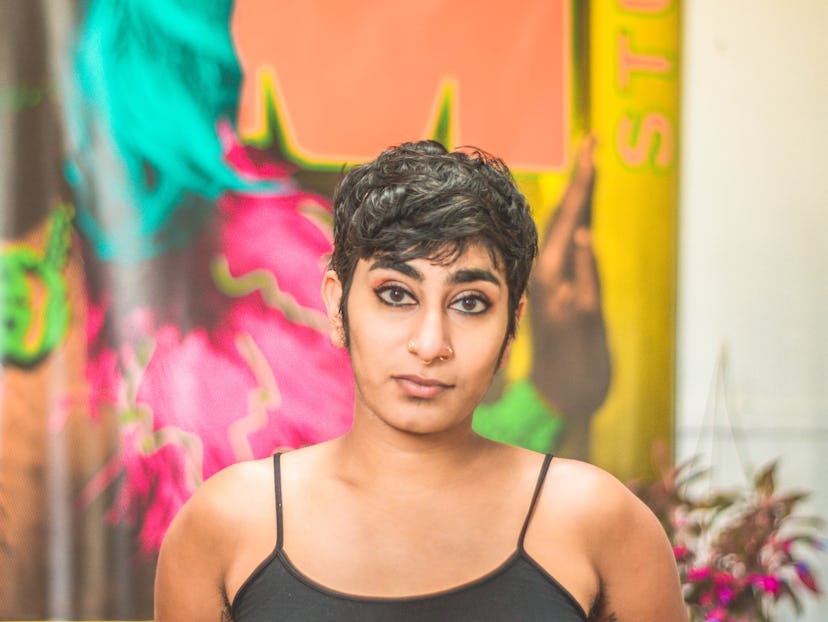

left=65, top=0, right=251, bottom=262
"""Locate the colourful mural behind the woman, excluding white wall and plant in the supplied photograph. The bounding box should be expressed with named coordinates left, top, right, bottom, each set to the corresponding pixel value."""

left=0, top=0, right=678, bottom=619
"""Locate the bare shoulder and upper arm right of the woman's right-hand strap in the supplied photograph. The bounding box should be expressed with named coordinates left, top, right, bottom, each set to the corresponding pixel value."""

left=532, top=458, right=687, bottom=622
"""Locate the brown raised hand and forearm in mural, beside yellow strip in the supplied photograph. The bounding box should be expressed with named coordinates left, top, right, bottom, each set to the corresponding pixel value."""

left=530, top=138, right=610, bottom=459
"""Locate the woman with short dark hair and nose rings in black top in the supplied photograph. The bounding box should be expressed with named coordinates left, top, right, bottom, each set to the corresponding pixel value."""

left=155, top=141, right=687, bottom=622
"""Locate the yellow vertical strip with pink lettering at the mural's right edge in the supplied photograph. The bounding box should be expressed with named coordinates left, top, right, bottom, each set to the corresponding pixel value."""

left=590, top=0, right=680, bottom=479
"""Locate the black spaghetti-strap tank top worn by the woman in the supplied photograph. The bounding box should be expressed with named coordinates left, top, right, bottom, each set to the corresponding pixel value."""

left=231, top=454, right=587, bottom=622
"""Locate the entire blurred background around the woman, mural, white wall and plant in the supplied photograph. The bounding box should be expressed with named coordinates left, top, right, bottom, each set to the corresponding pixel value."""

left=0, top=0, right=828, bottom=622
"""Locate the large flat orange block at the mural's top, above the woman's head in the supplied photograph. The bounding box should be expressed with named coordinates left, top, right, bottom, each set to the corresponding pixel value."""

left=232, top=0, right=572, bottom=170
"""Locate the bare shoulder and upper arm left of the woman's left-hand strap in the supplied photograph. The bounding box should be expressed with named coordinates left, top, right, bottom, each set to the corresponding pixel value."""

left=155, top=458, right=275, bottom=621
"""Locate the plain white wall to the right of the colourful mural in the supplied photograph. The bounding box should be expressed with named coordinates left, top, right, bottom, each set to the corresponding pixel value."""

left=676, top=0, right=828, bottom=622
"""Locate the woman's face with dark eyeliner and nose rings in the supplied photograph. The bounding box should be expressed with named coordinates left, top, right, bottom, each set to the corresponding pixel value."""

left=323, top=244, right=523, bottom=434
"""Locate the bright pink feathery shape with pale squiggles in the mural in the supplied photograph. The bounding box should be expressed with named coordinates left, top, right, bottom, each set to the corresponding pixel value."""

left=87, top=136, right=353, bottom=552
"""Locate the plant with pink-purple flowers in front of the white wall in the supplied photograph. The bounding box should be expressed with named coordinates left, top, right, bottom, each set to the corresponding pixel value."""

left=632, top=459, right=826, bottom=622
